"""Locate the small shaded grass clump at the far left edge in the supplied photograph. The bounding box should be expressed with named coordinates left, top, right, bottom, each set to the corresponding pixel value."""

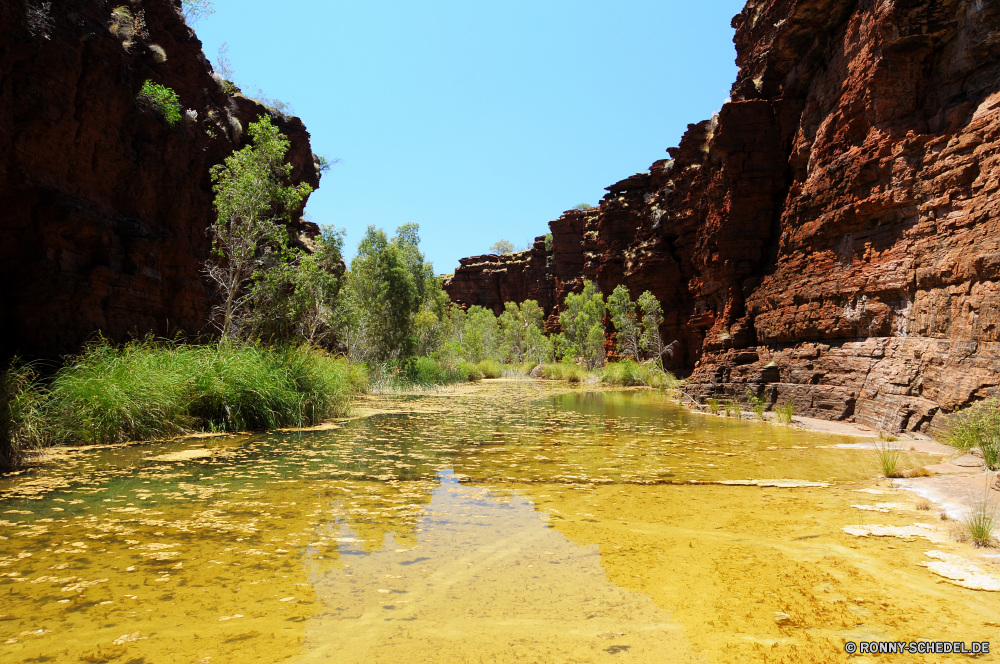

left=0, top=358, right=45, bottom=471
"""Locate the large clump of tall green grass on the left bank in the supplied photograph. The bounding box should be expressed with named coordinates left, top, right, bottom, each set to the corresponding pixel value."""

left=44, top=339, right=367, bottom=443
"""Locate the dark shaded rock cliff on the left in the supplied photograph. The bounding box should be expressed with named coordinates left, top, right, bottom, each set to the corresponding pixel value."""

left=0, top=0, right=319, bottom=357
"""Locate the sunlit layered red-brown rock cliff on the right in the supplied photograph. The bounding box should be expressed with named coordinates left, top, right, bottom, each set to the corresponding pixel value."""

left=452, top=0, right=1000, bottom=430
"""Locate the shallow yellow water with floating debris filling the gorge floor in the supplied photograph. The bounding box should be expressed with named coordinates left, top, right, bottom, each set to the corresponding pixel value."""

left=0, top=381, right=1000, bottom=664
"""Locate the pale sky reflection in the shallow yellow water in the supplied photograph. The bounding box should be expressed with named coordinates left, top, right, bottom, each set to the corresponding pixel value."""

left=295, top=473, right=702, bottom=662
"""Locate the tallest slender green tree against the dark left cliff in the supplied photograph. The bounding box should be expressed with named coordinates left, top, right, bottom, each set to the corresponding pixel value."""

left=204, top=118, right=312, bottom=339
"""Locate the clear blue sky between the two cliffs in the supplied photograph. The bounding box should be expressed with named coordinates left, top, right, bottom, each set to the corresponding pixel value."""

left=195, top=0, right=744, bottom=273
